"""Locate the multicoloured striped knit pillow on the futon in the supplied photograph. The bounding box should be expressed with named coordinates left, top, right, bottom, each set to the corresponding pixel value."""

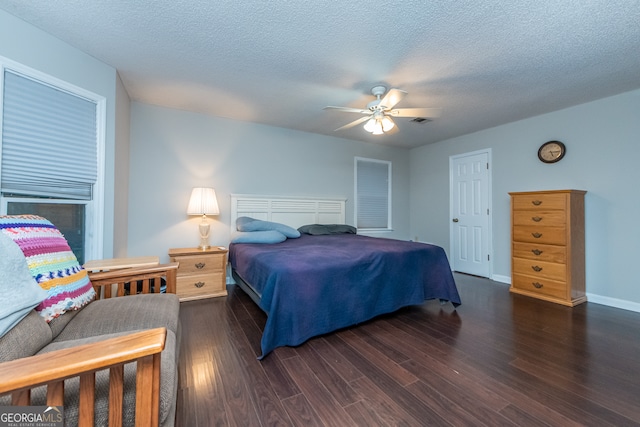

left=0, top=215, right=95, bottom=322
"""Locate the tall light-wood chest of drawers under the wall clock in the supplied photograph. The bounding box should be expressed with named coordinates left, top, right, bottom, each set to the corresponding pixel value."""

left=509, top=190, right=587, bottom=306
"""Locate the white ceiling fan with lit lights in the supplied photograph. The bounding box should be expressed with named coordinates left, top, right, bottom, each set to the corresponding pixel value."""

left=323, top=86, right=442, bottom=135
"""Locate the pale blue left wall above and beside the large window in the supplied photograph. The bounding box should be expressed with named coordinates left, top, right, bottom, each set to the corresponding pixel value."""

left=0, top=10, right=116, bottom=257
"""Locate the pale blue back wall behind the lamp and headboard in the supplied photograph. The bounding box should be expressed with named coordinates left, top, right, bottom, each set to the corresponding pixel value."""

left=128, top=102, right=409, bottom=260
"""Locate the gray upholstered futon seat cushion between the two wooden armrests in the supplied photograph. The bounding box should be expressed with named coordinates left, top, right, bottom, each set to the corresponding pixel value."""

left=54, top=294, right=180, bottom=342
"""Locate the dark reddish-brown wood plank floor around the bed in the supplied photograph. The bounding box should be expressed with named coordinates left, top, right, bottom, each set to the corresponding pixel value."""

left=177, top=274, right=640, bottom=427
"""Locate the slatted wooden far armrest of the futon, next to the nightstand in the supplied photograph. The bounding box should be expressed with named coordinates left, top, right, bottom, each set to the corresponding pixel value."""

left=88, top=262, right=179, bottom=298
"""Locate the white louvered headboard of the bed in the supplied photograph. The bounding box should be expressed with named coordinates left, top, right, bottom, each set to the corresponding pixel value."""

left=231, top=194, right=347, bottom=232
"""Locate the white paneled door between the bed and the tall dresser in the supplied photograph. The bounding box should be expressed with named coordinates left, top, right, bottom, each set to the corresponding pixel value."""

left=449, top=150, right=491, bottom=277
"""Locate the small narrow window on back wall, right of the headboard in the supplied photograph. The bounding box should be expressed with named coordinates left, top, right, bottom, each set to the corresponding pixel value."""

left=355, top=157, right=391, bottom=231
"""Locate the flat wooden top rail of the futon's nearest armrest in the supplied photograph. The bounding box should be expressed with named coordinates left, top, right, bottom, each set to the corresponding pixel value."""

left=0, top=328, right=167, bottom=394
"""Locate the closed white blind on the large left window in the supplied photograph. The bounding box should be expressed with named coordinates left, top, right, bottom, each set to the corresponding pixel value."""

left=0, top=69, right=97, bottom=200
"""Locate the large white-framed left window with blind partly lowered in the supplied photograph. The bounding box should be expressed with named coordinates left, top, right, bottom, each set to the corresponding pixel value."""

left=0, top=57, right=105, bottom=264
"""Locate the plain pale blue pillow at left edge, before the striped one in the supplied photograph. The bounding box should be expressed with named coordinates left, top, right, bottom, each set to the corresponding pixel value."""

left=0, top=233, right=47, bottom=337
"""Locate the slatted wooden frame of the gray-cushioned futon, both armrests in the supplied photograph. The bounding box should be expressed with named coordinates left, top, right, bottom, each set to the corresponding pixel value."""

left=0, top=262, right=178, bottom=426
